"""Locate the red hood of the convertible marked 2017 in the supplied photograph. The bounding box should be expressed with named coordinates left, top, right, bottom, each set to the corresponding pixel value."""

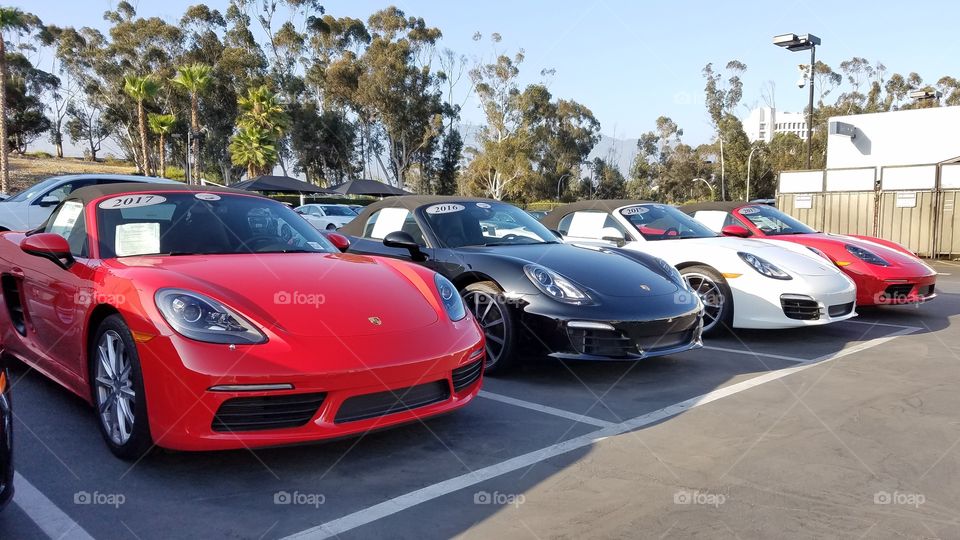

left=110, top=253, right=442, bottom=337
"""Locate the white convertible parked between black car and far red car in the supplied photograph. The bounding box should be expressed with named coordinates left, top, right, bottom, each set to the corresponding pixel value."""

left=543, top=200, right=856, bottom=332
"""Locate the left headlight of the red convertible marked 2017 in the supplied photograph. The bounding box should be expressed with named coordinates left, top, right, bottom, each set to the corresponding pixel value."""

left=156, top=289, right=267, bottom=345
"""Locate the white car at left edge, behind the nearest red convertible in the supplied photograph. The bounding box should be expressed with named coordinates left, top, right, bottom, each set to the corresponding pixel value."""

left=0, top=174, right=179, bottom=231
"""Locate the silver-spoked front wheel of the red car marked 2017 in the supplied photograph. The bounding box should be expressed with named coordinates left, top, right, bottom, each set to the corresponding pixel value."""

left=87, top=315, right=153, bottom=461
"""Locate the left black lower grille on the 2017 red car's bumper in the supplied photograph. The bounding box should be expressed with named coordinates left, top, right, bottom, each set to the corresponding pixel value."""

left=211, top=392, right=327, bottom=431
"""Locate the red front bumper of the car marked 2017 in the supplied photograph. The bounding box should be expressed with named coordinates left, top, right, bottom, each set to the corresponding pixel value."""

left=138, top=317, right=484, bottom=450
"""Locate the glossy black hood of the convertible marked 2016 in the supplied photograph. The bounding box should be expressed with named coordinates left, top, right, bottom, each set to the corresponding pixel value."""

left=455, top=244, right=679, bottom=298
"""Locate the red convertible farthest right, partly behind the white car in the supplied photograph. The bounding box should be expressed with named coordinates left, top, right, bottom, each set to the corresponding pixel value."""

left=681, top=202, right=937, bottom=306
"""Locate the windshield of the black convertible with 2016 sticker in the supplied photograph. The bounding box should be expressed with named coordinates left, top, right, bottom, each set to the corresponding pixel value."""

left=419, top=201, right=557, bottom=248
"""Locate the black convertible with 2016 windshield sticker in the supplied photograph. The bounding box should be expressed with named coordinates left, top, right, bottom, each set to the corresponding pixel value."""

left=340, top=196, right=703, bottom=373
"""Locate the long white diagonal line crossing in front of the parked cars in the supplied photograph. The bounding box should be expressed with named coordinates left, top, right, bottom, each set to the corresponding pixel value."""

left=284, top=329, right=914, bottom=540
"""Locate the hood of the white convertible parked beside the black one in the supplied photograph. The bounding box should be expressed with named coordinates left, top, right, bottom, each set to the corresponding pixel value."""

left=657, top=236, right=839, bottom=276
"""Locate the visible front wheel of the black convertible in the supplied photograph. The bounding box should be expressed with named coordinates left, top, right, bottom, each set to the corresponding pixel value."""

left=460, top=281, right=518, bottom=375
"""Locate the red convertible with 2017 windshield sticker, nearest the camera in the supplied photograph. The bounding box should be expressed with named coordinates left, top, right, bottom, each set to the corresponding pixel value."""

left=0, top=184, right=484, bottom=459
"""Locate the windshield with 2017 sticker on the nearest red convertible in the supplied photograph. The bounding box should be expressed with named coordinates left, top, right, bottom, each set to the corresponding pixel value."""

left=96, top=192, right=337, bottom=259
